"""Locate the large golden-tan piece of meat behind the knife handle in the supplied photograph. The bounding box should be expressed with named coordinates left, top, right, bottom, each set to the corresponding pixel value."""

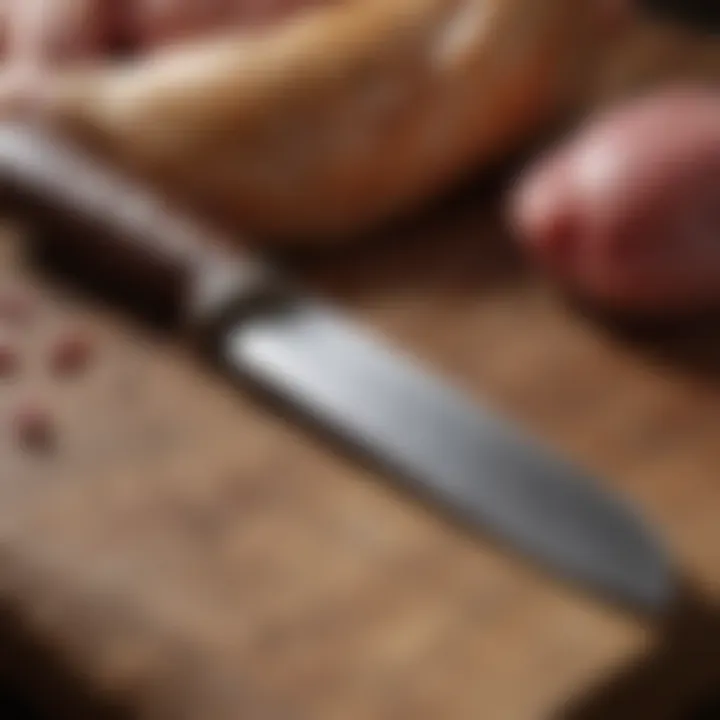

left=12, top=0, right=608, bottom=241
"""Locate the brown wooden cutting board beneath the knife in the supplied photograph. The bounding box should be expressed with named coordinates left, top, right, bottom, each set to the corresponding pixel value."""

left=0, top=15, right=720, bottom=720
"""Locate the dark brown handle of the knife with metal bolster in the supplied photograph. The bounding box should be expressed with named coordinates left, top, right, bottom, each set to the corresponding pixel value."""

left=0, top=124, right=282, bottom=334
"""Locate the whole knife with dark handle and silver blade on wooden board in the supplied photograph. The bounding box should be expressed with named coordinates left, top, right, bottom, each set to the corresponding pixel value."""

left=0, top=124, right=674, bottom=612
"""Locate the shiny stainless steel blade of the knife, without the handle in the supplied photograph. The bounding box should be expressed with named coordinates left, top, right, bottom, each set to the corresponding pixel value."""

left=224, top=301, right=673, bottom=610
